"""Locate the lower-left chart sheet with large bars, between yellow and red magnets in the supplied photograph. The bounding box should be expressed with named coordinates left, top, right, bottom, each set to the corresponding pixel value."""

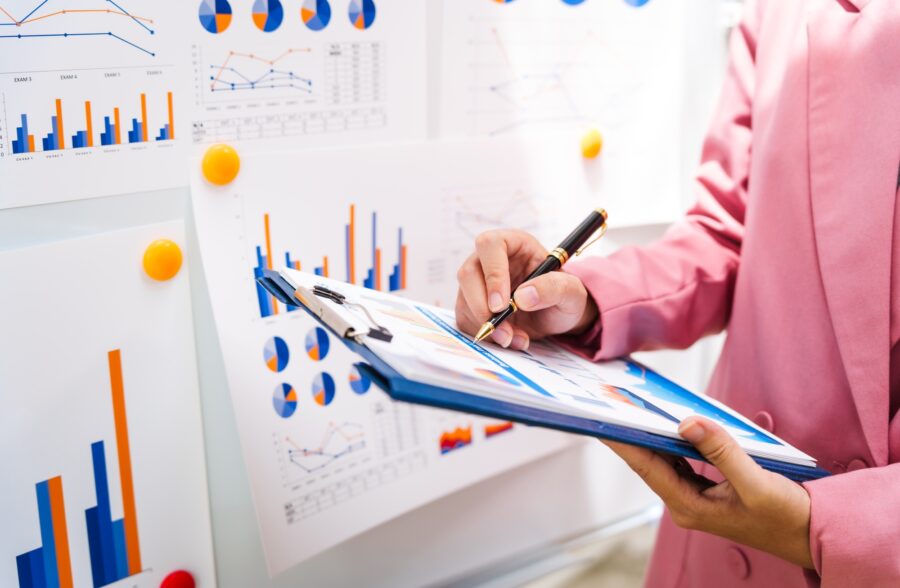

left=0, top=222, right=215, bottom=588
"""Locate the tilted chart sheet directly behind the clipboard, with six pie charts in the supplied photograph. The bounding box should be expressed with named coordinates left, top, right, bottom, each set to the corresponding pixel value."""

left=192, top=141, right=571, bottom=574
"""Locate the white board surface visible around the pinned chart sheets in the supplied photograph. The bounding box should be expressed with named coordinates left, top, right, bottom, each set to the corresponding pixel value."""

left=0, top=0, right=736, bottom=586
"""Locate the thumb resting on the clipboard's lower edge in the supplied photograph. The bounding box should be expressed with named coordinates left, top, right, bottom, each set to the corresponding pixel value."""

left=678, top=417, right=765, bottom=494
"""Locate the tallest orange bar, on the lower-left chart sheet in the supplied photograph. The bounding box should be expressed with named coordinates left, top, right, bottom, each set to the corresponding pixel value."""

left=109, top=349, right=142, bottom=576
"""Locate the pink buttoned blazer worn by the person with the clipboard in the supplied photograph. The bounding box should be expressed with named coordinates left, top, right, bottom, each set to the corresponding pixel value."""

left=569, top=0, right=900, bottom=588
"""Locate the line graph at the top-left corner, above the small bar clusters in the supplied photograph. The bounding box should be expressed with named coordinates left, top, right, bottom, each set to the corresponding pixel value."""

left=0, top=0, right=156, bottom=57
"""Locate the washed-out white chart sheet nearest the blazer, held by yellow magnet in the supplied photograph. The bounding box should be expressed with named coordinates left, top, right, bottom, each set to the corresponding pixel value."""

left=440, top=0, right=685, bottom=226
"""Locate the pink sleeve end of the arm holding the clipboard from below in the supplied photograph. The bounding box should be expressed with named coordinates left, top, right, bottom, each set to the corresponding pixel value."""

left=803, top=463, right=900, bottom=588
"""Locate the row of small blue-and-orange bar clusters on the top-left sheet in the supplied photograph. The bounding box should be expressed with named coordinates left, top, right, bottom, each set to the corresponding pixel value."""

left=12, top=92, right=175, bottom=155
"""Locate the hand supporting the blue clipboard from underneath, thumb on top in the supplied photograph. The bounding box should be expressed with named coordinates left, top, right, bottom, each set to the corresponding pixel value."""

left=604, top=417, right=813, bottom=568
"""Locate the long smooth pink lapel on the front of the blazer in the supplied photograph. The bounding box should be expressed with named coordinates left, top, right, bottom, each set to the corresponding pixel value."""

left=808, top=0, right=900, bottom=465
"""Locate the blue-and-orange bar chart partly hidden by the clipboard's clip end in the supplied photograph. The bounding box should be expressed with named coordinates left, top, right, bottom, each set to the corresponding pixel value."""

left=253, top=204, right=409, bottom=318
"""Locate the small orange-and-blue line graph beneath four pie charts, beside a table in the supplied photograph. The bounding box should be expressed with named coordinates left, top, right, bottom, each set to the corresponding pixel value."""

left=208, top=47, right=313, bottom=94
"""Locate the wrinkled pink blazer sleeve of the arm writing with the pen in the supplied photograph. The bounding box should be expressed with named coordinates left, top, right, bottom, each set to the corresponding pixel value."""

left=563, top=1, right=758, bottom=360
